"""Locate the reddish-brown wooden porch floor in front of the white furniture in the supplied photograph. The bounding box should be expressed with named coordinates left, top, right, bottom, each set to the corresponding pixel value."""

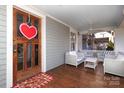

left=47, top=63, right=124, bottom=88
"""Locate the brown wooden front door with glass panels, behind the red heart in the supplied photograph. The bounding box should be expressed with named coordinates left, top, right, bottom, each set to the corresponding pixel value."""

left=13, top=8, right=41, bottom=84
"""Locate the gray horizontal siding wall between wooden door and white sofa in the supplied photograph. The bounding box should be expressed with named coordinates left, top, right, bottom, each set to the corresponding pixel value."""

left=46, top=17, right=69, bottom=70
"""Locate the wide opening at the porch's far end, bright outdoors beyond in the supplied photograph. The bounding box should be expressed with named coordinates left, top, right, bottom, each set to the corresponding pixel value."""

left=82, top=31, right=114, bottom=50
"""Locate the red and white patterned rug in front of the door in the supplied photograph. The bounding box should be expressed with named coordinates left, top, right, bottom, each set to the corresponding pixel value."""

left=13, top=73, right=53, bottom=88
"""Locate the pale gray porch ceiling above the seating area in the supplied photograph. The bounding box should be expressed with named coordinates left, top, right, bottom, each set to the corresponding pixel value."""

left=35, top=5, right=124, bottom=31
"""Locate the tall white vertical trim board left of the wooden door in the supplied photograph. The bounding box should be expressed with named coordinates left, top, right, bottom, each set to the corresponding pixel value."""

left=6, top=5, right=13, bottom=88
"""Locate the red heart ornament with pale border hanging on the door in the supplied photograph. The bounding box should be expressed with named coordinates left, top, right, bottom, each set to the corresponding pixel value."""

left=19, top=23, right=37, bottom=39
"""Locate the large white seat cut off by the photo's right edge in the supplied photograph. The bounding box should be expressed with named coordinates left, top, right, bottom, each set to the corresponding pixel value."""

left=104, top=54, right=124, bottom=77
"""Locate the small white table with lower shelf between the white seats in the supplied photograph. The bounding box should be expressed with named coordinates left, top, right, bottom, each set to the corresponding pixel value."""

left=84, top=58, right=97, bottom=70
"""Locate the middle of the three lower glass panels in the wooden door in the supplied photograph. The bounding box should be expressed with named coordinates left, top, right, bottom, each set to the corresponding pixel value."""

left=27, top=44, right=32, bottom=68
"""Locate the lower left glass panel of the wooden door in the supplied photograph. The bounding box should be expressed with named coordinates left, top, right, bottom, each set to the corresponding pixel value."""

left=17, top=44, right=24, bottom=71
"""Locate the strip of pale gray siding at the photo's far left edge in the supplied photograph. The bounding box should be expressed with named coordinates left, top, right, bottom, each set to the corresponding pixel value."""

left=0, top=5, right=6, bottom=88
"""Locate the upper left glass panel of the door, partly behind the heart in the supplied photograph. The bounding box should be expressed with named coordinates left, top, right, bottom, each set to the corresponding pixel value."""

left=16, top=14, right=23, bottom=37
